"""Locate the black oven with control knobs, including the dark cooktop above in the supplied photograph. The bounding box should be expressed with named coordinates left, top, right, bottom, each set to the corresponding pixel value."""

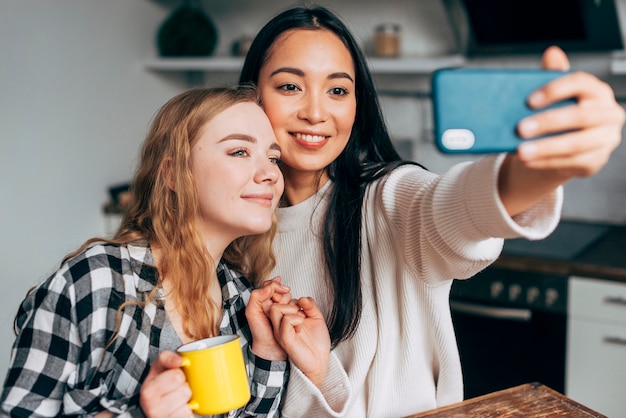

left=450, top=221, right=610, bottom=399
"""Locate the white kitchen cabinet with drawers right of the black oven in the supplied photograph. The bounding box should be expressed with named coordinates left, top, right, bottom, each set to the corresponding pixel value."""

left=565, top=276, right=626, bottom=417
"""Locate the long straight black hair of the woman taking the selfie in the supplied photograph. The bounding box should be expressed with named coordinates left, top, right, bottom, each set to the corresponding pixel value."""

left=239, top=6, right=420, bottom=346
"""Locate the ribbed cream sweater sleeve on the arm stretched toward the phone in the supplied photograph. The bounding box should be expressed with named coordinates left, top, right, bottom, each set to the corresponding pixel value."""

left=376, top=155, right=563, bottom=280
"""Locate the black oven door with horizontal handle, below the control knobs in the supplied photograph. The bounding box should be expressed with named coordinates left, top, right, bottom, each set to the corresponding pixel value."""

left=450, top=299, right=566, bottom=399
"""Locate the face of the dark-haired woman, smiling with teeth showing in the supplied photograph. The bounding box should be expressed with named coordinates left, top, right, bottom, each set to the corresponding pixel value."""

left=258, top=29, right=356, bottom=191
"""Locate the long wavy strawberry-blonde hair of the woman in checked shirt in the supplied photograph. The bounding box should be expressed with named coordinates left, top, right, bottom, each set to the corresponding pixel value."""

left=66, top=86, right=276, bottom=339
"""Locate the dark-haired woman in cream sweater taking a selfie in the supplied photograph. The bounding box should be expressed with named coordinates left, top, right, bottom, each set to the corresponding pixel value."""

left=235, top=7, right=624, bottom=418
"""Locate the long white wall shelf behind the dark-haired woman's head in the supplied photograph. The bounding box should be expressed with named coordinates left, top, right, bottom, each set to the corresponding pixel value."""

left=145, top=55, right=465, bottom=75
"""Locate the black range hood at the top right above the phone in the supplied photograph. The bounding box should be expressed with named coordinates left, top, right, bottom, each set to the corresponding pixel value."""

left=444, top=0, right=623, bottom=56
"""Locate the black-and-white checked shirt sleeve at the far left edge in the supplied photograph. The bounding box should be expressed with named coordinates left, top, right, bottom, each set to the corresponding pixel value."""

left=0, top=274, right=79, bottom=416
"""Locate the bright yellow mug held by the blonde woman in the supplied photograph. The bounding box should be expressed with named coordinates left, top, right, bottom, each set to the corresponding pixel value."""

left=176, top=335, right=250, bottom=415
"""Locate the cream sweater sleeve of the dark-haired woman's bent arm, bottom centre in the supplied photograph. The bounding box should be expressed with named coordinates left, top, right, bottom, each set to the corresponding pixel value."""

left=281, top=351, right=352, bottom=418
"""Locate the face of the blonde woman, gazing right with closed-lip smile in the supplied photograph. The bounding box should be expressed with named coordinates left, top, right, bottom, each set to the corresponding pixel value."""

left=191, top=102, right=284, bottom=252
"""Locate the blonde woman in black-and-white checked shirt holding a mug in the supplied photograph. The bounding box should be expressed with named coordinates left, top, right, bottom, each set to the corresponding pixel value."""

left=1, top=87, right=330, bottom=416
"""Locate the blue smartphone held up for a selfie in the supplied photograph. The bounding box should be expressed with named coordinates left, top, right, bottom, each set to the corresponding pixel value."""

left=431, top=68, right=575, bottom=154
